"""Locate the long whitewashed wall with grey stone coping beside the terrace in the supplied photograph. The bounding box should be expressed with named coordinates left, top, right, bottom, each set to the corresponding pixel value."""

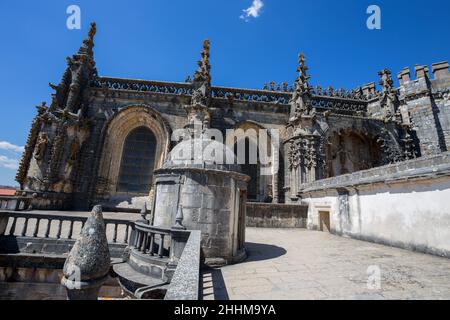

left=303, top=153, right=450, bottom=257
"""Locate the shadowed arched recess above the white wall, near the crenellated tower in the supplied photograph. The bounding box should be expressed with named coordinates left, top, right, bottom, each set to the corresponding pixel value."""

left=326, top=131, right=381, bottom=178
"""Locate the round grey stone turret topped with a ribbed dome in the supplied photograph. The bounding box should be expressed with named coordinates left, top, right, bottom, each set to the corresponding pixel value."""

left=153, top=134, right=250, bottom=266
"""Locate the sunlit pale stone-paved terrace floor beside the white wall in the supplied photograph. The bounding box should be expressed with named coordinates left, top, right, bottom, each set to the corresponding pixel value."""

left=203, top=228, right=450, bottom=300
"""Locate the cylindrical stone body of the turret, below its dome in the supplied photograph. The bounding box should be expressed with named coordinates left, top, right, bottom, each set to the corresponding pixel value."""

left=153, top=168, right=246, bottom=265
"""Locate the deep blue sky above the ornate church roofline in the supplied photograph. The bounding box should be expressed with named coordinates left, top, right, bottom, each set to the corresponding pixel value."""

left=0, top=0, right=450, bottom=185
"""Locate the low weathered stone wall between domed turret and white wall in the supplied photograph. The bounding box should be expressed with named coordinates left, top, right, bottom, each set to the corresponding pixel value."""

left=247, top=202, right=308, bottom=228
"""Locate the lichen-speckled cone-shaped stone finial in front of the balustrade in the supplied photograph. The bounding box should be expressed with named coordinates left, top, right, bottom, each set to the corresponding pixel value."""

left=61, top=206, right=111, bottom=300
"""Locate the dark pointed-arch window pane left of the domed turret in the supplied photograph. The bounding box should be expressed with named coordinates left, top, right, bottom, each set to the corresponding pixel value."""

left=117, top=127, right=156, bottom=194
